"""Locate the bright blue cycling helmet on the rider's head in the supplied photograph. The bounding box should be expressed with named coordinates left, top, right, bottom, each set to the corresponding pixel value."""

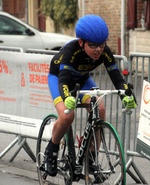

left=75, top=15, right=108, bottom=44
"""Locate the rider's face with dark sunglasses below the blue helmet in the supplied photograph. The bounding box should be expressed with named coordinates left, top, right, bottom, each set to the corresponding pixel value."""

left=79, top=40, right=106, bottom=60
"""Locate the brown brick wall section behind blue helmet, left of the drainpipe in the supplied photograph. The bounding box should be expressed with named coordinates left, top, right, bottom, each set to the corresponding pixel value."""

left=79, top=0, right=121, bottom=54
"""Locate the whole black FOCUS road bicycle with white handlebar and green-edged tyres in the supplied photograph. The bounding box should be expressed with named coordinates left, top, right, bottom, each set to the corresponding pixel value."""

left=36, top=83, right=136, bottom=185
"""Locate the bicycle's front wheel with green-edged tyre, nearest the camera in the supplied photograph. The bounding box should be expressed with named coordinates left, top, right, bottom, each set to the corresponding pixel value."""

left=85, top=121, right=126, bottom=185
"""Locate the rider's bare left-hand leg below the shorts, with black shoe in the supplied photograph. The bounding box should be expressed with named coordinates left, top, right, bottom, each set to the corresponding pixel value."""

left=45, top=102, right=74, bottom=176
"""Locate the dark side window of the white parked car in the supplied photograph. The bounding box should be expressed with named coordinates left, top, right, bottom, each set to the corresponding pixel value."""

left=0, top=16, right=27, bottom=35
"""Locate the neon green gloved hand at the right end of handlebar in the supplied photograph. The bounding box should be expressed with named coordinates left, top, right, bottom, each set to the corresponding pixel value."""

left=122, top=96, right=136, bottom=110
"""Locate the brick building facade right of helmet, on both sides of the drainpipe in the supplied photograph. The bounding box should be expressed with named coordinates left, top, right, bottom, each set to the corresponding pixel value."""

left=79, top=0, right=150, bottom=57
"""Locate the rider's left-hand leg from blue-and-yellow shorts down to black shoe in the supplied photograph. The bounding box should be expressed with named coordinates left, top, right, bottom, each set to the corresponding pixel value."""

left=45, top=74, right=74, bottom=176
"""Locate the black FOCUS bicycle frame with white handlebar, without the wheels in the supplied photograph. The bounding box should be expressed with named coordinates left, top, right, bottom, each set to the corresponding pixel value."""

left=65, top=89, right=130, bottom=180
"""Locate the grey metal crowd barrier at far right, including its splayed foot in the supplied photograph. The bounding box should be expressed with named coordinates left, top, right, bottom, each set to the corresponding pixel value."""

left=125, top=53, right=150, bottom=184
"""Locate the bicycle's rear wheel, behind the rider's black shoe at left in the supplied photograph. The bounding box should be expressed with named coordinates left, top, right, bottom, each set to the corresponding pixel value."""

left=36, top=114, right=72, bottom=185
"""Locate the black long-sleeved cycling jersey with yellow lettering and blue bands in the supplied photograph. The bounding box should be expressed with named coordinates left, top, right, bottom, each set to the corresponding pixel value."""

left=50, top=39, right=125, bottom=100
